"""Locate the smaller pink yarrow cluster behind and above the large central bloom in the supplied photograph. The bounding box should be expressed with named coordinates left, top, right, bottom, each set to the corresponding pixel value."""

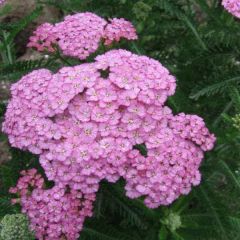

left=28, top=12, right=137, bottom=60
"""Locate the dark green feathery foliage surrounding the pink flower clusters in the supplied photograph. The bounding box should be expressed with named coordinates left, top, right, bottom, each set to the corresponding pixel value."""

left=0, top=0, right=240, bottom=240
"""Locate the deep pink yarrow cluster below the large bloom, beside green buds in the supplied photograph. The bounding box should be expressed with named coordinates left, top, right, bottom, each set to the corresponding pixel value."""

left=10, top=169, right=95, bottom=240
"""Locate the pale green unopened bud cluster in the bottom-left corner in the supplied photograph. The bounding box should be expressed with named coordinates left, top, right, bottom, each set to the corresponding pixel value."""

left=0, top=214, right=34, bottom=240
